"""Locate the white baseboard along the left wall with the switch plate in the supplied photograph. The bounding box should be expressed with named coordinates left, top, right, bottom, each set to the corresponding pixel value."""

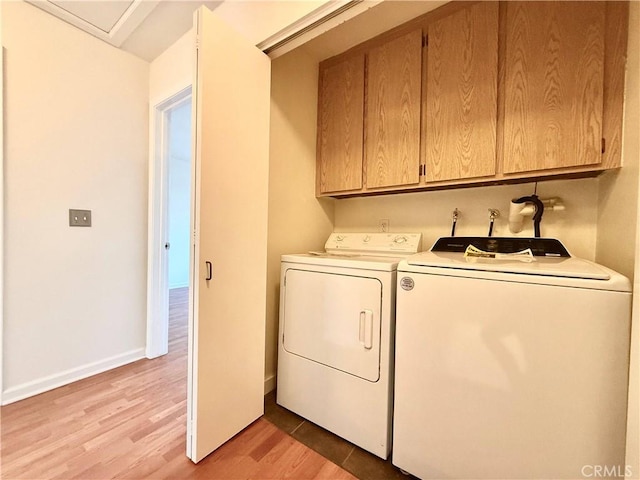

left=2, top=348, right=145, bottom=405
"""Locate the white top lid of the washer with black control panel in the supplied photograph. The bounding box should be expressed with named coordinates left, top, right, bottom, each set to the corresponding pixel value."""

left=407, top=252, right=611, bottom=280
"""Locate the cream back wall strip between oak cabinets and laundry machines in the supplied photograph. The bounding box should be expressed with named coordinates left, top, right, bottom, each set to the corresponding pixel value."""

left=335, top=179, right=598, bottom=260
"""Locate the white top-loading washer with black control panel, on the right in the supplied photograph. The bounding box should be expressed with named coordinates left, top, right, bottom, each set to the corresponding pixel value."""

left=393, top=238, right=631, bottom=479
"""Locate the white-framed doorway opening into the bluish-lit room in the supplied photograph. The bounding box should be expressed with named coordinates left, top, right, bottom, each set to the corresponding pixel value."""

left=146, top=86, right=193, bottom=358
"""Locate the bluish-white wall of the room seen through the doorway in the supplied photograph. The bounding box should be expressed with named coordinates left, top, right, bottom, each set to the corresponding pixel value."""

left=169, top=100, right=191, bottom=288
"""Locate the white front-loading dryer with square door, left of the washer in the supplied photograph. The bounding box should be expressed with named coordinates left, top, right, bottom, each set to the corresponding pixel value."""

left=277, top=233, right=421, bottom=459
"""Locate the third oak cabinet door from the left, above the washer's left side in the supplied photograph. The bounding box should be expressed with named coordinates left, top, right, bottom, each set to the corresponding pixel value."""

left=425, top=2, right=498, bottom=182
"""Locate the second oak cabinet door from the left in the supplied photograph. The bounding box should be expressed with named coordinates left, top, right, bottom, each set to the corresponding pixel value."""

left=366, top=30, right=422, bottom=188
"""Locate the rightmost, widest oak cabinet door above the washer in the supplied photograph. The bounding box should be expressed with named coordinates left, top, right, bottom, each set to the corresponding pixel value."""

left=503, top=2, right=605, bottom=173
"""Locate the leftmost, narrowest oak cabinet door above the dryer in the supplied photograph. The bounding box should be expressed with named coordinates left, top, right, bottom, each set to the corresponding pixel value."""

left=317, top=55, right=364, bottom=193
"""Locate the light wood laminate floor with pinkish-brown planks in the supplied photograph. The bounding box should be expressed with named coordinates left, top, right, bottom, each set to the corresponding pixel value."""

left=0, top=289, right=355, bottom=480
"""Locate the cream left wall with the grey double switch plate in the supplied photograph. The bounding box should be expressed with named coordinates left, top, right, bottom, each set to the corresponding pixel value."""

left=2, top=2, right=149, bottom=403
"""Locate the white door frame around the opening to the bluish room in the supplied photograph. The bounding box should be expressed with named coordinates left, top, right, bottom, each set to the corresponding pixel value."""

left=145, top=83, right=192, bottom=358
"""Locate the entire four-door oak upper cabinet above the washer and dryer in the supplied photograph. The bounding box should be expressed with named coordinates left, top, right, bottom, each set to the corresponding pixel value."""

left=316, top=0, right=629, bottom=196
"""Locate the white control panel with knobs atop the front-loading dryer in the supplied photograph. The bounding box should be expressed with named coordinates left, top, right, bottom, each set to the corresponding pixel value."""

left=324, top=232, right=422, bottom=256
